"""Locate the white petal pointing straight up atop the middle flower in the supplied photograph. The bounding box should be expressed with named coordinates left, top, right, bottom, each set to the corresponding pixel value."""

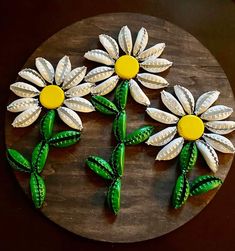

left=118, top=26, right=132, bottom=54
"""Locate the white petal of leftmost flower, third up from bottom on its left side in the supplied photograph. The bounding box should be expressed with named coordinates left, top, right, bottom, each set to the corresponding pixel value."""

left=10, top=82, right=40, bottom=98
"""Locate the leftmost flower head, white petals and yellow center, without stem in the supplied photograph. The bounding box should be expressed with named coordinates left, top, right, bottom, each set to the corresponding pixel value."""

left=7, top=56, right=95, bottom=130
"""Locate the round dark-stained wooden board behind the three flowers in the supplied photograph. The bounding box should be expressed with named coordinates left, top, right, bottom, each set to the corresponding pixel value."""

left=5, top=13, right=235, bottom=242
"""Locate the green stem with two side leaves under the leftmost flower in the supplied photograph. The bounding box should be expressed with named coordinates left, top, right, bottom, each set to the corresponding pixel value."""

left=7, top=110, right=80, bottom=208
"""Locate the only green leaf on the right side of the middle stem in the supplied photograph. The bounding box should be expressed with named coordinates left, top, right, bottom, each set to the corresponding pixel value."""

left=125, top=126, right=154, bottom=145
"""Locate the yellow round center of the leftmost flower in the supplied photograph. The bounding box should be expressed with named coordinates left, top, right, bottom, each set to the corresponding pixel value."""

left=39, top=85, right=64, bottom=109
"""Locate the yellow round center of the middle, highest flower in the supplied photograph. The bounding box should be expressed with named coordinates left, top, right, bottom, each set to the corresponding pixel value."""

left=115, top=55, right=140, bottom=79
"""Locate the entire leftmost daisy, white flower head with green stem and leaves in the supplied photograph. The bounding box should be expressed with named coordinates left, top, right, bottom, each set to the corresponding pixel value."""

left=7, top=56, right=90, bottom=208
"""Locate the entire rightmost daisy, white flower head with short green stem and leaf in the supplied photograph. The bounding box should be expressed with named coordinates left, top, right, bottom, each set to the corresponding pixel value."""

left=146, top=85, right=235, bottom=208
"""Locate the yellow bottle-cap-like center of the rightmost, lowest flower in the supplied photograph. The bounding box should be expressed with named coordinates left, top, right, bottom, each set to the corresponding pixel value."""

left=177, top=115, right=204, bottom=140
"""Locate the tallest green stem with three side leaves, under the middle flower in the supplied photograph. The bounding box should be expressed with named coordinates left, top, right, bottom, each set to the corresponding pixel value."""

left=86, top=80, right=154, bottom=215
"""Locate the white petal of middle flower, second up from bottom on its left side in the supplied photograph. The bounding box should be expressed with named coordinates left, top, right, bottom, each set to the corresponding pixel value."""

left=85, top=66, right=114, bottom=83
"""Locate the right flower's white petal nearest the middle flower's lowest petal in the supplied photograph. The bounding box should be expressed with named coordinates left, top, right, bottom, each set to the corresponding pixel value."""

left=146, top=107, right=179, bottom=125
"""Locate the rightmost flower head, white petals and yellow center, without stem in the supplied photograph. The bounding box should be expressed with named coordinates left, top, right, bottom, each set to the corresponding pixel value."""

left=146, top=85, right=235, bottom=172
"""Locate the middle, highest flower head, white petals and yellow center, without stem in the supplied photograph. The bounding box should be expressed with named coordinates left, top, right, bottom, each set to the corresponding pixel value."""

left=84, top=26, right=172, bottom=106
